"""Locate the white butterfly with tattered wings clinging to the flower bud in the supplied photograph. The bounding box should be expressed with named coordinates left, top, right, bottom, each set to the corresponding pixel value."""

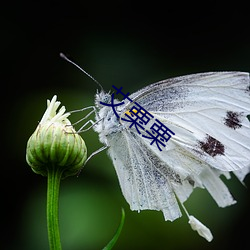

left=60, top=54, right=250, bottom=241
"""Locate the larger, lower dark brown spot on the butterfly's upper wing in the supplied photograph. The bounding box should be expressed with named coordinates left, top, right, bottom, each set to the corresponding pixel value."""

left=199, top=135, right=225, bottom=157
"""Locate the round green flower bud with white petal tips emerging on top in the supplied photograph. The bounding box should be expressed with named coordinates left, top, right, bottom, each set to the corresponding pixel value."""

left=26, top=96, right=87, bottom=177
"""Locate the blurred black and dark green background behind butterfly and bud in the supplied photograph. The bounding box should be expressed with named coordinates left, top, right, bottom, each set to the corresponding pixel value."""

left=0, top=1, right=250, bottom=250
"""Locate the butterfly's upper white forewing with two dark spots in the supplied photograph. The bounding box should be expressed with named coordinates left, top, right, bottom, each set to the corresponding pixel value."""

left=127, top=72, right=250, bottom=174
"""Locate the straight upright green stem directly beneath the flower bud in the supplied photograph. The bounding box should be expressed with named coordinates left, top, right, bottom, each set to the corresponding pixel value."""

left=47, top=167, right=62, bottom=250
